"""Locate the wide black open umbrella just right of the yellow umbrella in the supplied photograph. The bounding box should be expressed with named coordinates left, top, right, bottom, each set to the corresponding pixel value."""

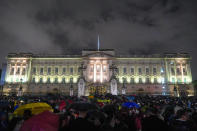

left=69, top=102, right=98, bottom=111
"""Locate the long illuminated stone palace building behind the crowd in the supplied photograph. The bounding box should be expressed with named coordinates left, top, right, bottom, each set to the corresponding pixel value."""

left=3, top=49, right=193, bottom=96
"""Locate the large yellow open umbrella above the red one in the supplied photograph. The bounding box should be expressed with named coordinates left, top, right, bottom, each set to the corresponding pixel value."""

left=14, top=102, right=53, bottom=116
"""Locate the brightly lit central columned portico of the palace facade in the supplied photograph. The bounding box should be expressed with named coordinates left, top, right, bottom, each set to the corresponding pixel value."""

left=78, top=49, right=115, bottom=96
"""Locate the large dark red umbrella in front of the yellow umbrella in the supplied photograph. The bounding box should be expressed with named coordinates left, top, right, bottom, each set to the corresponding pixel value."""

left=20, top=111, right=59, bottom=131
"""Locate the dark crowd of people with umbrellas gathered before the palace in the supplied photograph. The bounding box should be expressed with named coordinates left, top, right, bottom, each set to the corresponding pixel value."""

left=0, top=94, right=197, bottom=131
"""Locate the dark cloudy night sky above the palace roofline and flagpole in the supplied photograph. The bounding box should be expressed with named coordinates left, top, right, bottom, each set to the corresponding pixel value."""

left=0, top=0, right=197, bottom=80
